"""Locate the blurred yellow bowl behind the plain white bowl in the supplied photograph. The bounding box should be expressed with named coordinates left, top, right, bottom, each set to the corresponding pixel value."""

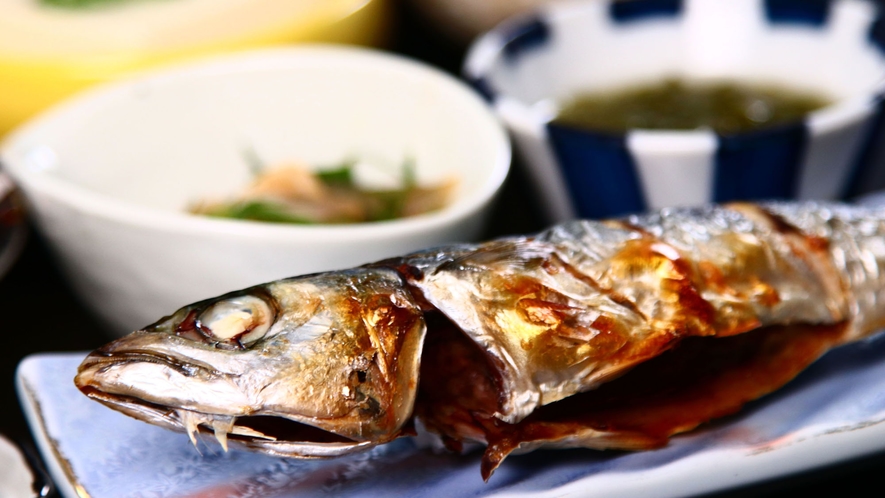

left=0, top=0, right=389, bottom=136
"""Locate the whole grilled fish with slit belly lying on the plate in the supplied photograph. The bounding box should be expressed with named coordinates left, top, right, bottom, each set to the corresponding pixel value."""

left=75, top=203, right=885, bottom=479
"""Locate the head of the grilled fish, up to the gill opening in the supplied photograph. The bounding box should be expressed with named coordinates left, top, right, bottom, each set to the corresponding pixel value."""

left=74, top=268, right=426, bottom=457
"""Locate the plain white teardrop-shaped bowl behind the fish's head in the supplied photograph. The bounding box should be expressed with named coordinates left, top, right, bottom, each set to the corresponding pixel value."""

left=0, top=46, right=510, bottom=335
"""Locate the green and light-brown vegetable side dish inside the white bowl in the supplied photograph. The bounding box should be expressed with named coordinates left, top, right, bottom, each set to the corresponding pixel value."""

left=189, top=161, right=457, bottom=225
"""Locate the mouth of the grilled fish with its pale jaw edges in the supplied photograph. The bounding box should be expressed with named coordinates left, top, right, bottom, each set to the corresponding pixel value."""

left=74, top=350, right=377, bottom=458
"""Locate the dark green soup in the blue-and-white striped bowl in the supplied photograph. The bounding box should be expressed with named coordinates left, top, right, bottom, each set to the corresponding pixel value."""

left=554, top=79, right=832, bottom=135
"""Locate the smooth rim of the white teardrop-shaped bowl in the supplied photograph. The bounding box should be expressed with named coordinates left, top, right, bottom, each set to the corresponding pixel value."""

left=0, top=43, right=511, bottom=242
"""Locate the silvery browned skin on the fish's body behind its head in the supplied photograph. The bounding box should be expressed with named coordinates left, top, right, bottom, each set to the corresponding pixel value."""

left=407, top=203, right=885, bottom=469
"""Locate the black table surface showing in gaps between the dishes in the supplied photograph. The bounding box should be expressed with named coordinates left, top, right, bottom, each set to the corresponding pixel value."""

left=0, top=2, right=885, bottom=498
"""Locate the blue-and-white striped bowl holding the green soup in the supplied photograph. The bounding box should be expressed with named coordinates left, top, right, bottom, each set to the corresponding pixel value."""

left=464, top=0, right=885, bottom=221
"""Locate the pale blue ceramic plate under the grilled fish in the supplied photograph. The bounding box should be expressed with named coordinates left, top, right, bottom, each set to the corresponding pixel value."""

left=17, top=335, right=885, bottom=498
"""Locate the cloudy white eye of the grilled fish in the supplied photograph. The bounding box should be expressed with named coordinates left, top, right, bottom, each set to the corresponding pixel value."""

left=196, top=296, right=274, bottom=347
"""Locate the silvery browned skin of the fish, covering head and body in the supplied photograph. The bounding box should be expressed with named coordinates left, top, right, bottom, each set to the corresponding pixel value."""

left=75, top=203, right=885, bottom=478
